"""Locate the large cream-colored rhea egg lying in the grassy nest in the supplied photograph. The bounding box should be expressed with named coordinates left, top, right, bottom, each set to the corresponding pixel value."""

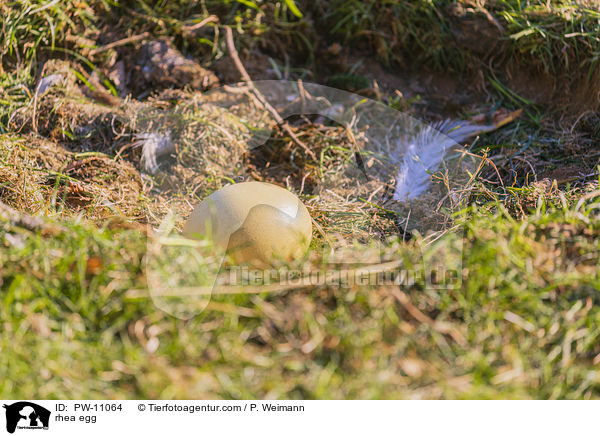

left=183, top=182, right=312, bottom=265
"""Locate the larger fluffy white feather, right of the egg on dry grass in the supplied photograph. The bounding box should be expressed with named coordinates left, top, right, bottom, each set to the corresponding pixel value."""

left=394, top=120, right=496, bottom=201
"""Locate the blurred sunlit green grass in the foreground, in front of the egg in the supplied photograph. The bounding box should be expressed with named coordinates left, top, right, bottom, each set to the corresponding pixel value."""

left=0, top=192, right=600, bottom=398
